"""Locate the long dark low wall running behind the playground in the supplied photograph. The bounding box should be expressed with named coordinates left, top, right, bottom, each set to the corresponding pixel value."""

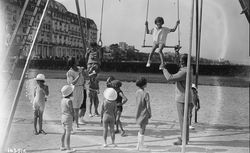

left=18, top=59, right=250, bottom=77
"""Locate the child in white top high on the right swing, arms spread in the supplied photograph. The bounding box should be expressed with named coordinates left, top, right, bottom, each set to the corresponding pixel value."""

left=145, top=17, right=180, bottom=70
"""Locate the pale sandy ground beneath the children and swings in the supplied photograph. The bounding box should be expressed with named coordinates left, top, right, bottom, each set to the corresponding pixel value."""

left=0, top=76, right=249, bottom=153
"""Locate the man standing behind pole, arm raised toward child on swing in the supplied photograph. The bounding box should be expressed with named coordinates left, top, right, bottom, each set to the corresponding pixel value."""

left=162, top=54, right=192, bottom=145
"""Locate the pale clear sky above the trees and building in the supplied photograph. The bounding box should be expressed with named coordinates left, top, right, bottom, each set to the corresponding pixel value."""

left=55, top=0, right=250, bottom=65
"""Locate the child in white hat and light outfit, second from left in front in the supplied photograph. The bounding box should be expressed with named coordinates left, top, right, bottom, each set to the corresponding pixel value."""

left=60, top=85, right=75, bottom=153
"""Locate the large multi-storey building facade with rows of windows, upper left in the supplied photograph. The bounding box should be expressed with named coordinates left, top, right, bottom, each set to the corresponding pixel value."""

left=3, top=0, right=97, bottom=58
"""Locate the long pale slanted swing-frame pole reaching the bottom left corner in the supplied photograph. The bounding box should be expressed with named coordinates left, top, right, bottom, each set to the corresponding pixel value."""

left=1, top=0, right=50, bottom=152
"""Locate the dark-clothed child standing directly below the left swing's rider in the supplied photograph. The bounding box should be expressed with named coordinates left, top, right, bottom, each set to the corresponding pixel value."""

left=89, top=74, right=100, bottom=117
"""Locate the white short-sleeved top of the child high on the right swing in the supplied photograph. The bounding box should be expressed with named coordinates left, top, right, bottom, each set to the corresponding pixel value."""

left=150, top=27, right=171, bottom=45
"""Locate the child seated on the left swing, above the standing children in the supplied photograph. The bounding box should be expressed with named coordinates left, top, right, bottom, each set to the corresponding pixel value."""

left=85, top=42, right=102, bottom=74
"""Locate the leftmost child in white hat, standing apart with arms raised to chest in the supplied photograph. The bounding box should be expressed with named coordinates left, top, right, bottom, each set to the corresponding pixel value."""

left=33, top=74, right=49, bottom=135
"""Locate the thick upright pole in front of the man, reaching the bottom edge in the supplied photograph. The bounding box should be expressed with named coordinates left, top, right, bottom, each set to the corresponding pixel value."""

left=181, top=0, right=194, bottom=153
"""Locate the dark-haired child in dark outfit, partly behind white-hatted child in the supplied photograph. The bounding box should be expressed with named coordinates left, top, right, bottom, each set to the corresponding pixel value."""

left=112, top=80, right=128, bottom=137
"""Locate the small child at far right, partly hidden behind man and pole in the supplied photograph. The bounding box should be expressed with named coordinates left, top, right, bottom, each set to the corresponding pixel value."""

left=189, top=84, right=200, bottom=130
